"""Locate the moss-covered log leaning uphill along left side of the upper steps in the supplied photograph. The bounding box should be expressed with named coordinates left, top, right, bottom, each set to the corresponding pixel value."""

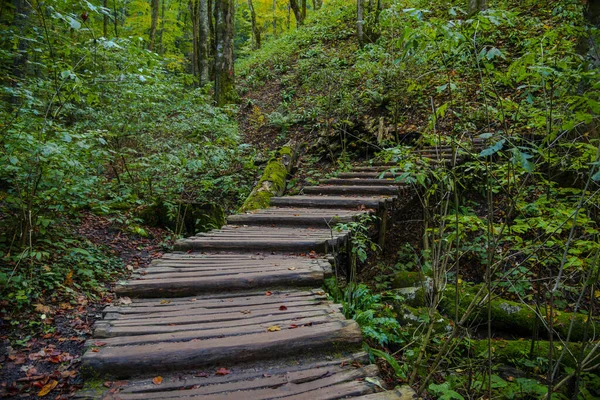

left=240, top=141, right=297, bottom=212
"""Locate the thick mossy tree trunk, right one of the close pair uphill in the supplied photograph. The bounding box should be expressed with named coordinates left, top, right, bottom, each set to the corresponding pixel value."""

left=215, top=0, right=235, bottom=106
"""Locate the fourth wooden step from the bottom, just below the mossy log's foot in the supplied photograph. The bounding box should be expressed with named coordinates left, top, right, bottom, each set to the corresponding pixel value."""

left=175, top=226, right=348, bottom=254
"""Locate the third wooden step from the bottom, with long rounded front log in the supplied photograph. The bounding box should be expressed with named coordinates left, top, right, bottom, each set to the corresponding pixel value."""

left=115, top=257, right=331, bottom=298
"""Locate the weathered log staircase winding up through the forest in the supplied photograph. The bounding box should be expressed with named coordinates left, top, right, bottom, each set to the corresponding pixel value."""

left=79, top=162, right=407, bottom=399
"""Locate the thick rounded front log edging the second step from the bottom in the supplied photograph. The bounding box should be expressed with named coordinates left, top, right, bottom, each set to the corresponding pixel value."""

left=82, top=321, right=362, bottom=376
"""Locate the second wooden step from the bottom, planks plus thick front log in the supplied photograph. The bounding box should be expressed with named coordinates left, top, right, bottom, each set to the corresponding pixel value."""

left=83, top=294, right=362, bottom=377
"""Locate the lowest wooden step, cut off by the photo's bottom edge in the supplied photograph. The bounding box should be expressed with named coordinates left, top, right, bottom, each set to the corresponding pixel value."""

left=76, top=353, right=410, bottom=400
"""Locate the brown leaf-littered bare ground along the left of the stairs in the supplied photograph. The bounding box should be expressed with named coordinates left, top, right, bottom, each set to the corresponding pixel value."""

left=0, top=213, right=168, bottom=399
